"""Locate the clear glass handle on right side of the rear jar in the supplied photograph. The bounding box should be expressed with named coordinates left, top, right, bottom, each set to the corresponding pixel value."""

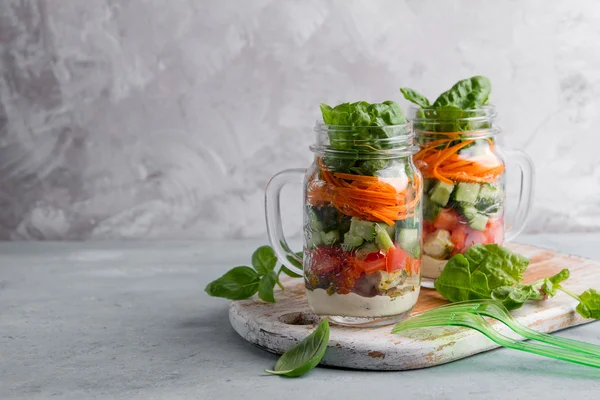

left=504, top=150, right=535, bottom=242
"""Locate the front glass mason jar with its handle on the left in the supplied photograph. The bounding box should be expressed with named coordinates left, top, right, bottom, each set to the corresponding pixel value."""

left=266, top=123, right=422, bottom=326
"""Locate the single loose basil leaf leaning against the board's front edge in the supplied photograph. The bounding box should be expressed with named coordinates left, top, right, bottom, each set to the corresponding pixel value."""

left=265, top=319, right=329, bottom=378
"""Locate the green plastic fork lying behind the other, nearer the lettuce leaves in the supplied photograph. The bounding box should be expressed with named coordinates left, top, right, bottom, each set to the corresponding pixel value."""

left=434, top=300, right=600, bottom=357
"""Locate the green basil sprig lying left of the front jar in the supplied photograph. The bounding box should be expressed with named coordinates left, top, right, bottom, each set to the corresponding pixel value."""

left=204, top=246, right=302, bottom=303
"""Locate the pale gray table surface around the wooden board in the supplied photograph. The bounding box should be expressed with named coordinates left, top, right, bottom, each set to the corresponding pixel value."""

left=0, top=234, right=600, bottom=400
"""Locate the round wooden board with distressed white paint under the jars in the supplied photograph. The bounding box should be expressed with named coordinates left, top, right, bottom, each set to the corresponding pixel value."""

left=229, top=244, right=600, bottom=370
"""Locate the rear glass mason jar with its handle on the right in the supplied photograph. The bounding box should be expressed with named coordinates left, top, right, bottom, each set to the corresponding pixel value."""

left=409, top=105, right=534, bottom=287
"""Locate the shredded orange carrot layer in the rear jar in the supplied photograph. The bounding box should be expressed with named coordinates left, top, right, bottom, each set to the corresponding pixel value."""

left=414, top=132, right=504, bottom=184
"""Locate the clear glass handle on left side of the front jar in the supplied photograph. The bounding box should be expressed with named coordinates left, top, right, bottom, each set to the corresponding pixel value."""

left=265, top=168, right=306, bottom=275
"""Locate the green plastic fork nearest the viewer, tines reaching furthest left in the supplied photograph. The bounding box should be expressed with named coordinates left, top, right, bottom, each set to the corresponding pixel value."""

left=392, top=307, right=600, bottom=368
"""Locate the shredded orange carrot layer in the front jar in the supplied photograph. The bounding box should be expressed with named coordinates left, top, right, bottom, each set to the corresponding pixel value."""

left=307, top=159, right=422, bottom=225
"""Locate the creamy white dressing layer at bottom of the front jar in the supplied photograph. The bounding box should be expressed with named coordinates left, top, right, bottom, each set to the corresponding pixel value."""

left=306, top=286, right=419, bottom=318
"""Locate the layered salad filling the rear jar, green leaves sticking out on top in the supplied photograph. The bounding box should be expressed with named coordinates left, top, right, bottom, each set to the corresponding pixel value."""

left=401, top=76, right=505, bottom=279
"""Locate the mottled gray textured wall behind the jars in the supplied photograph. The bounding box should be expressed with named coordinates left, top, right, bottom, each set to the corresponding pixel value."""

left=0, top=0, right=600, bottom=239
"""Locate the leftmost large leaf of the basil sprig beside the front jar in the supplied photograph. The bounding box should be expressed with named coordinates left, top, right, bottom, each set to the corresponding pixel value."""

left=204, top=267, right=260, bottom=300
